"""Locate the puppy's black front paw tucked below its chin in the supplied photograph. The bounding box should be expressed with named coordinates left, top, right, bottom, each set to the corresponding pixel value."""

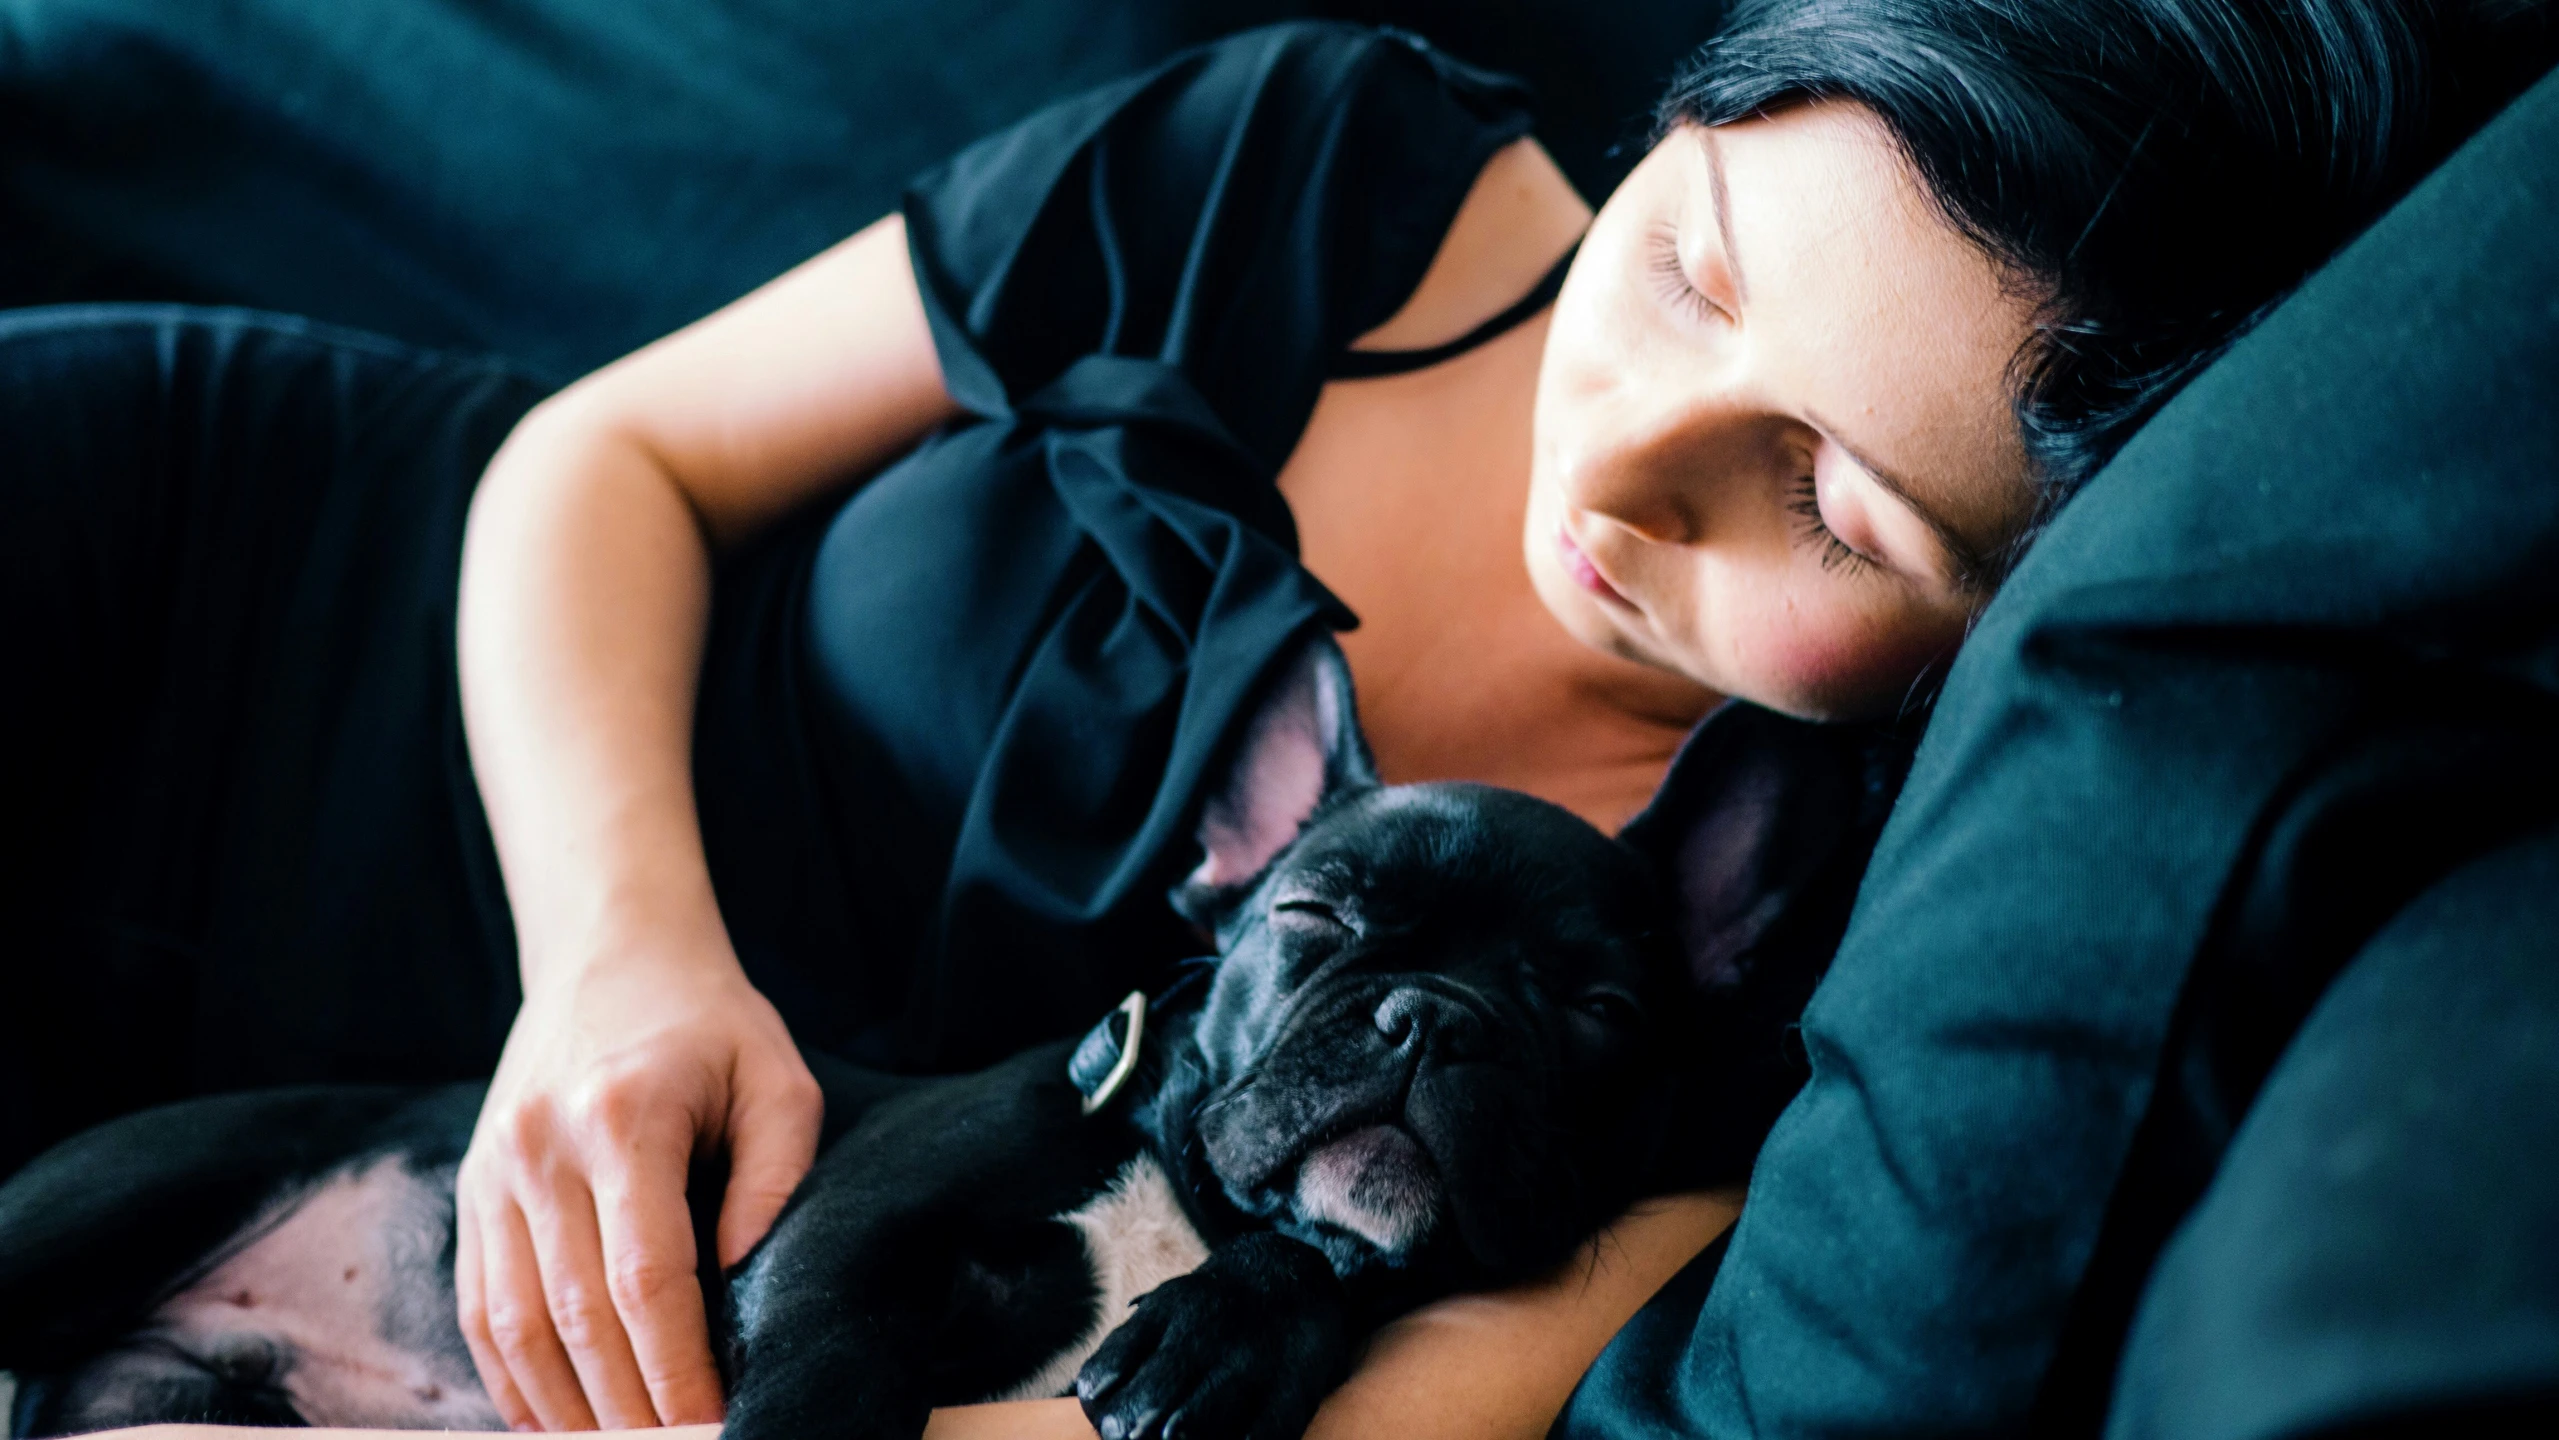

left=1075, top=1235, right=1356, bottom=1440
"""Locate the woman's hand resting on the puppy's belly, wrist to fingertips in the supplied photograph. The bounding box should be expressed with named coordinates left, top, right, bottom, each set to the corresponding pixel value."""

left=453, top=949, right=821, bottom=1430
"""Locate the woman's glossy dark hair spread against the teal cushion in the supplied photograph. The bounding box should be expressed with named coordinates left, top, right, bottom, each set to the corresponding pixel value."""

left=1661, top=0, right=2559, bottom=565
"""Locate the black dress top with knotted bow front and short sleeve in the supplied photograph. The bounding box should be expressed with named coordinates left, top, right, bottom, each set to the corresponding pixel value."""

left=696, top=26, right=1530, bottom=1067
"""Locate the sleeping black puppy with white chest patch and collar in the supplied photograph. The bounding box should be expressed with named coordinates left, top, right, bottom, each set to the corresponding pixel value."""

left=0, top=642, right=1681, bottom=1440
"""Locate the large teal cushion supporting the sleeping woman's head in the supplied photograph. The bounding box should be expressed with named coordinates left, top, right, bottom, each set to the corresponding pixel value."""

left=1564, top=62, right=2559, bottom=1435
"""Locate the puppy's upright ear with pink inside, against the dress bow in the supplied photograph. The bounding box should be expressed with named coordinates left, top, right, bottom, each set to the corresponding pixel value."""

left=1172, top=634, right=1377, bottom=926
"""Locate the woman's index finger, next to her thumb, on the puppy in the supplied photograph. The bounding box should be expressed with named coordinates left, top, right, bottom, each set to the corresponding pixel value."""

left=596, top=1136, right=722, bottom=1425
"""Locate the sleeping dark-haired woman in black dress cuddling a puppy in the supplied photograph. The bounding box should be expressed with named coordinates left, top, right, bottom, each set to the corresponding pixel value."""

left=0, top=0, right=2539, bottom=1435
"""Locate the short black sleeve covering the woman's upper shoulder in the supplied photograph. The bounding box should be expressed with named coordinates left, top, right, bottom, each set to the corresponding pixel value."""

left=903, top=20, right=1553, bottom=450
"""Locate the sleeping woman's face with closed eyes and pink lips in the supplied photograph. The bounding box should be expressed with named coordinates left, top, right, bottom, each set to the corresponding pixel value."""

left=1528, top=102, right=2034, bottom=719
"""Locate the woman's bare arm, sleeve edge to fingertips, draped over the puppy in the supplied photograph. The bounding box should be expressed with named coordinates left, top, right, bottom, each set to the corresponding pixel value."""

left=456, top=217, right=955, bottom=1430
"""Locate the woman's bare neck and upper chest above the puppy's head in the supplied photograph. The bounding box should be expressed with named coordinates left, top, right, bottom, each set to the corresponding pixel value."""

left=1280, top=315, right=1717, bottom=829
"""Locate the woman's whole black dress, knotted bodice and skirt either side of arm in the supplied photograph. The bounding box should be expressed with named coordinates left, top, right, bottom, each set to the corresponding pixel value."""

left=0, top=26, right=1889, bottom=1174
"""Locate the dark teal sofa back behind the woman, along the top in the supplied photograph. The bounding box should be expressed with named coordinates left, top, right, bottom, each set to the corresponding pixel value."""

left=0, top=0, right=1722, bottom=379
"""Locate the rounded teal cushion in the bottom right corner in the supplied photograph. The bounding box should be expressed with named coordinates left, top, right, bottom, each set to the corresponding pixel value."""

left=2109, top=831, right=2559, bottom=1440
